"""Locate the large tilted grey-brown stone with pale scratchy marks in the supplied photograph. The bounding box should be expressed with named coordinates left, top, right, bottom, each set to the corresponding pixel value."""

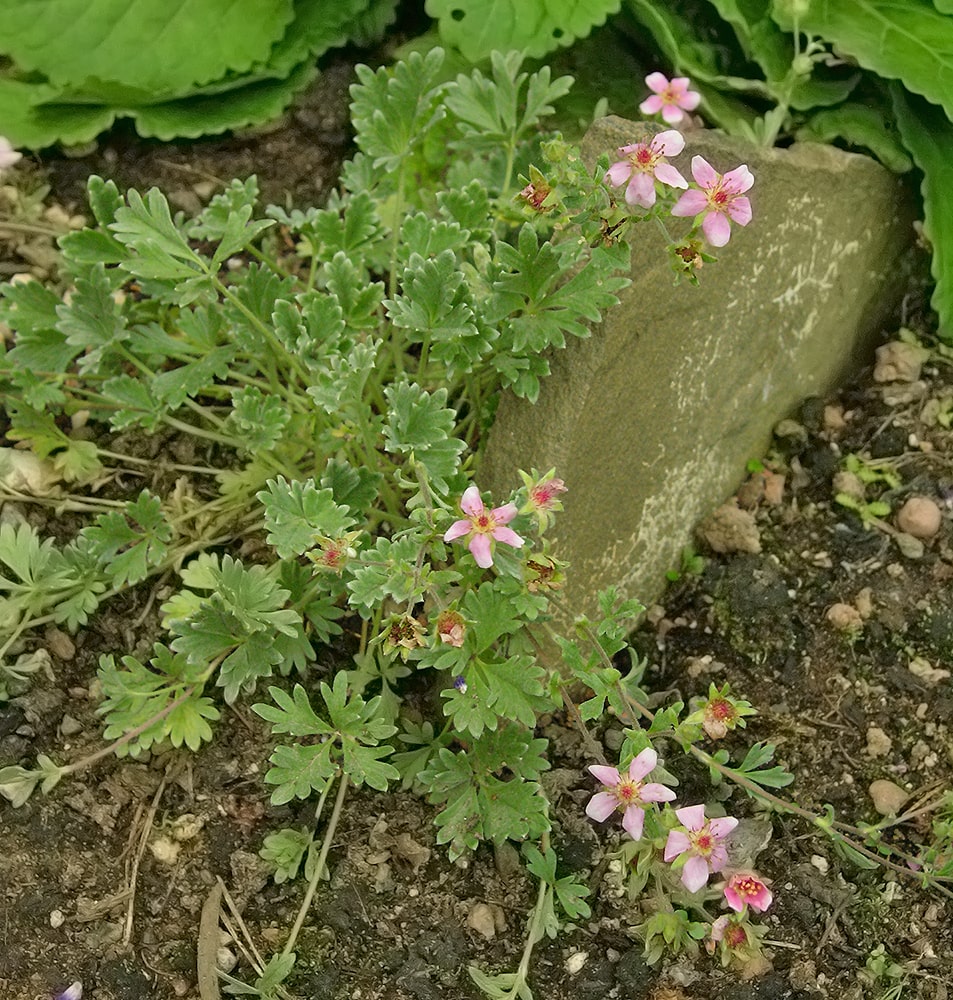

left=480, top=117, right=913, bottom=614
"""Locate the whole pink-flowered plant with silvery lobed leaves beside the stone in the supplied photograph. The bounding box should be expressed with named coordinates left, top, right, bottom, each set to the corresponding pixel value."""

left=0, top=50, right=944, bottom=998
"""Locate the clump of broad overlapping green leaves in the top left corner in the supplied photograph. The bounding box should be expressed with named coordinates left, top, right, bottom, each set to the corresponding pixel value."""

left=0, top=0, right=397, bottom=149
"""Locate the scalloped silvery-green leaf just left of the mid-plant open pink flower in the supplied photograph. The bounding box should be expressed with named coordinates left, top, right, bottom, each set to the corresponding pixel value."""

left=256, top=476, right=354, bottom=559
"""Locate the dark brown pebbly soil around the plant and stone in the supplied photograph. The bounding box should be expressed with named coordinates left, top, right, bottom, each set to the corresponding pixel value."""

left=0, top=47, right=953, bottom=1000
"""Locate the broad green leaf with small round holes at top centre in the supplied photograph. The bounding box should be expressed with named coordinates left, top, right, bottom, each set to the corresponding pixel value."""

left=426, top=0, right=620, bottom=63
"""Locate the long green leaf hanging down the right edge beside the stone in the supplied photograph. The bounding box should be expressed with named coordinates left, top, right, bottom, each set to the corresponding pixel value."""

left=891, top=86, right=953, bottom=341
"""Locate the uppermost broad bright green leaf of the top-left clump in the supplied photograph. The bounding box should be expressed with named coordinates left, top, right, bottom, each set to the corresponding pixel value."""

left=0, top=0, right=294, bottom=94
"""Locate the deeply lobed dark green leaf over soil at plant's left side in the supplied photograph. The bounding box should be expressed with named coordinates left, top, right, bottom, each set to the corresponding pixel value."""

left=82, top=490, right=172, bottom=587
